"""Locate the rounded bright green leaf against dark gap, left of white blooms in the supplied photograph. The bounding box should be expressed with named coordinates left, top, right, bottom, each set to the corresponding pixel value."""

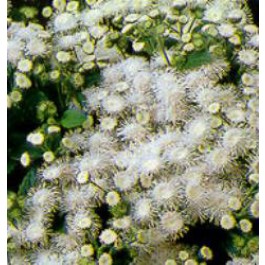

left=61, top=110, right=86, bottom=129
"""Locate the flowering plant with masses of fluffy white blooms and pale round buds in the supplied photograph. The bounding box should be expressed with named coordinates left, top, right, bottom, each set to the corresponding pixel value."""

left=8, top=0, right=259, bottom=265
